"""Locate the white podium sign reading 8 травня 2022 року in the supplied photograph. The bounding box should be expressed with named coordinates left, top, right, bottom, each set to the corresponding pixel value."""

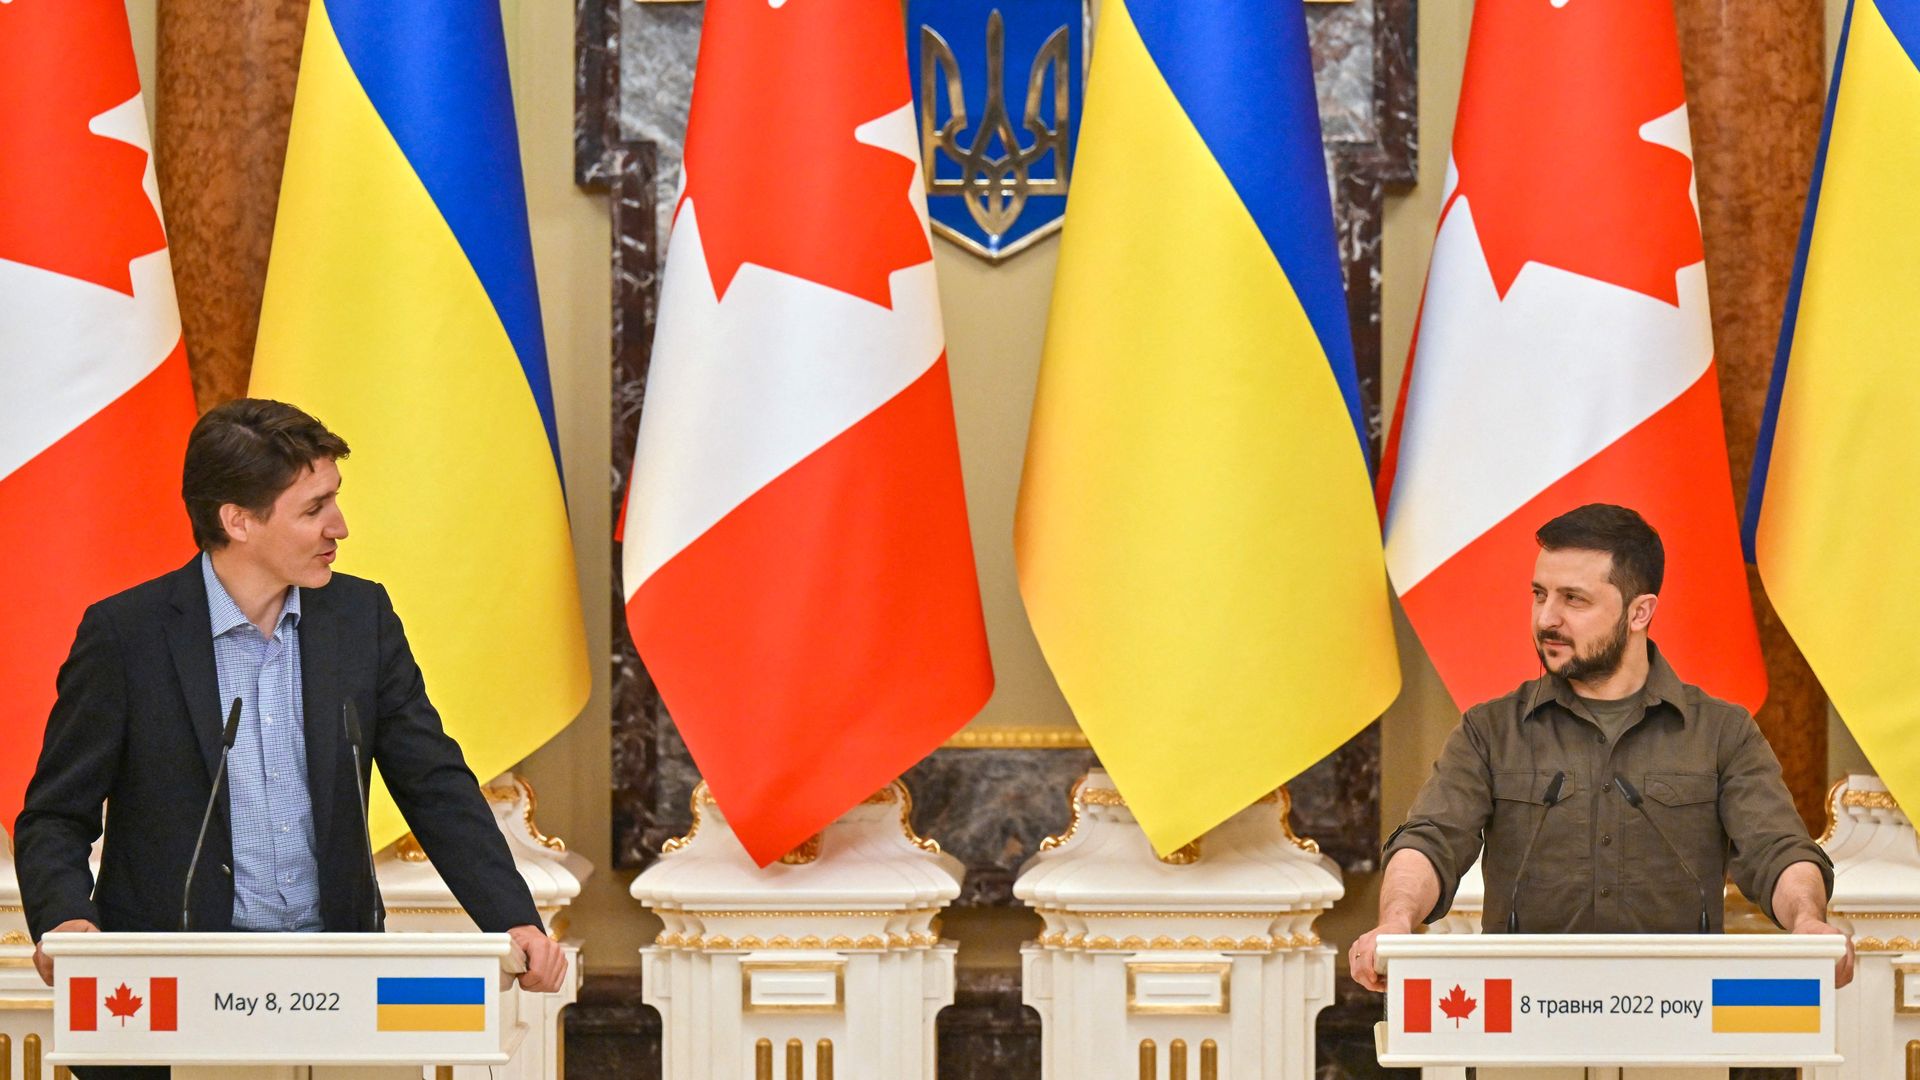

left=1379, top=934, right=1847, bottom=1067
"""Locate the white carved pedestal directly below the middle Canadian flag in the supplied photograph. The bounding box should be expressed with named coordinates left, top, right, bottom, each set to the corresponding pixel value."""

left=632, top=782, right=964, bottom=1080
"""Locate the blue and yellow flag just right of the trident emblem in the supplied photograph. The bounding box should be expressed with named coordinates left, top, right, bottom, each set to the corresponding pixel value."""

left=1016, top=0, right=1400, bottom=853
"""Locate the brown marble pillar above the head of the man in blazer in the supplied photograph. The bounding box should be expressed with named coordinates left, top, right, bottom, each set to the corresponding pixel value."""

left=154, top=0, right=307, bottom=409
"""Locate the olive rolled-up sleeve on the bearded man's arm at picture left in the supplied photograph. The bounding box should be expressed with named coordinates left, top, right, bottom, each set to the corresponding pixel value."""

left=1380, top=705, right=1494, bottom=922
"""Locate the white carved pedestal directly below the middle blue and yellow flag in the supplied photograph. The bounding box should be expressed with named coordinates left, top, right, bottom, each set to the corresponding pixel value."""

left=1014, top=771, right=1342, bottom=1080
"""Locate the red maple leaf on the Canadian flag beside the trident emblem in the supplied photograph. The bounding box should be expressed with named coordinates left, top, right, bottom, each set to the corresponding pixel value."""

left=684, top=0, right=933, bottom=307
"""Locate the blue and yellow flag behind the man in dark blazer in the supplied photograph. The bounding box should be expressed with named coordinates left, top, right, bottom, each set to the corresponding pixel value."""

left=250, top=0, right=589, bottom=844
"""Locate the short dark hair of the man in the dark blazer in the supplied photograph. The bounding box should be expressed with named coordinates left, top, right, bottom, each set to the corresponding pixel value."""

left=180, top=398, right=348, bottom=552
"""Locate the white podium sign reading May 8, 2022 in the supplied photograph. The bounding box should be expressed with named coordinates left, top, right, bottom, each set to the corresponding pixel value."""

left=46, top=934, right=516, bottom=1065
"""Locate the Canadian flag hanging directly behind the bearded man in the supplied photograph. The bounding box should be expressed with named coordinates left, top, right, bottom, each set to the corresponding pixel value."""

left=1379, top=0, right=1766, bottom=709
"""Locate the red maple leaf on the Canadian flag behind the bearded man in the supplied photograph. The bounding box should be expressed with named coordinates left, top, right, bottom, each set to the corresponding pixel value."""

left=1453, top=0, right=1703, bottom=304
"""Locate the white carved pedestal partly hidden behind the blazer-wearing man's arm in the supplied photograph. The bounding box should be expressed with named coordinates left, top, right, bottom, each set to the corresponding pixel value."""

left=374, top=774, right=593, bottom=1080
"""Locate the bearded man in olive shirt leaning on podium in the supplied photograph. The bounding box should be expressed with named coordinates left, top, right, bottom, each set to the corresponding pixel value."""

left=1348, top=503, right=1853, bottom=990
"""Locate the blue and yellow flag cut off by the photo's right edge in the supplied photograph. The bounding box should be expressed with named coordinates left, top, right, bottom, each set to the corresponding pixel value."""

left=1747, top=0, right=1920, bottom=807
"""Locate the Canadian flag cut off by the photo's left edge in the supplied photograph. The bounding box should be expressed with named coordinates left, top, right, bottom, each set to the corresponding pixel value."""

left=0, top=0, right=194, bottom=828
